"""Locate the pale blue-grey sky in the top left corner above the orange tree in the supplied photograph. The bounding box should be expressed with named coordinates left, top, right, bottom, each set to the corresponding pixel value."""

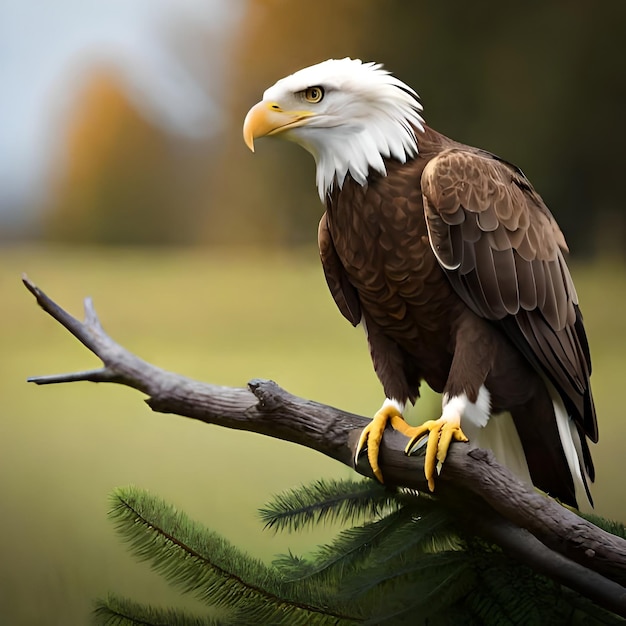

left=0, top=0, right=244, bottom=228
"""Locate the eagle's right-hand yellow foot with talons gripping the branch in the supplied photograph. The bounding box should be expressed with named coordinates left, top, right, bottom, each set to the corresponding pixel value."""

left=404, top=416, right=469, bottom=491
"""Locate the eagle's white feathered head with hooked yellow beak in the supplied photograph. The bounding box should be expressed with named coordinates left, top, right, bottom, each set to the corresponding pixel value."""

left=243, top=58, right=424, bottom=201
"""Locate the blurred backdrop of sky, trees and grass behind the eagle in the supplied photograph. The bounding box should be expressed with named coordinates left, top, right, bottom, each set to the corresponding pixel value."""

left=0, top=0, right=626, bottom=624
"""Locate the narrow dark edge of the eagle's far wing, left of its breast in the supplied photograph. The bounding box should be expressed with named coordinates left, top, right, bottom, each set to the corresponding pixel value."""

left=317, top=213, right=361, bottom=326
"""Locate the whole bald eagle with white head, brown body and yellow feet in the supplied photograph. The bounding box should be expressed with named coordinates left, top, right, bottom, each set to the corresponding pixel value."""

left=243, top=58, right=598, bottom=506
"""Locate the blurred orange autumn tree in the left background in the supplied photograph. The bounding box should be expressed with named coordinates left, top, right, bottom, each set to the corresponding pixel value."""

left=44, top=70, right=211, bottom=244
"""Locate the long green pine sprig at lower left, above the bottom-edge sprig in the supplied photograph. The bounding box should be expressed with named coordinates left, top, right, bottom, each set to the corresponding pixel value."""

left=110, top=487, right=357, bottom=624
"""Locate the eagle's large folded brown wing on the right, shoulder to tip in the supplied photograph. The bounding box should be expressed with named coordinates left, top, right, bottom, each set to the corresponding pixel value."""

left=421, top=148, right=598, bottom=448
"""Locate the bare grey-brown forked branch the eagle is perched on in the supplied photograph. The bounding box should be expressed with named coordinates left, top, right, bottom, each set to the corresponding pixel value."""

left=23, top=276, right=626, bottom=617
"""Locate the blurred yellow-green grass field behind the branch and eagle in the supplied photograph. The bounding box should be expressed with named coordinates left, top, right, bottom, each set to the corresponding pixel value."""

left=0, top=248, right=626, bottom=625
